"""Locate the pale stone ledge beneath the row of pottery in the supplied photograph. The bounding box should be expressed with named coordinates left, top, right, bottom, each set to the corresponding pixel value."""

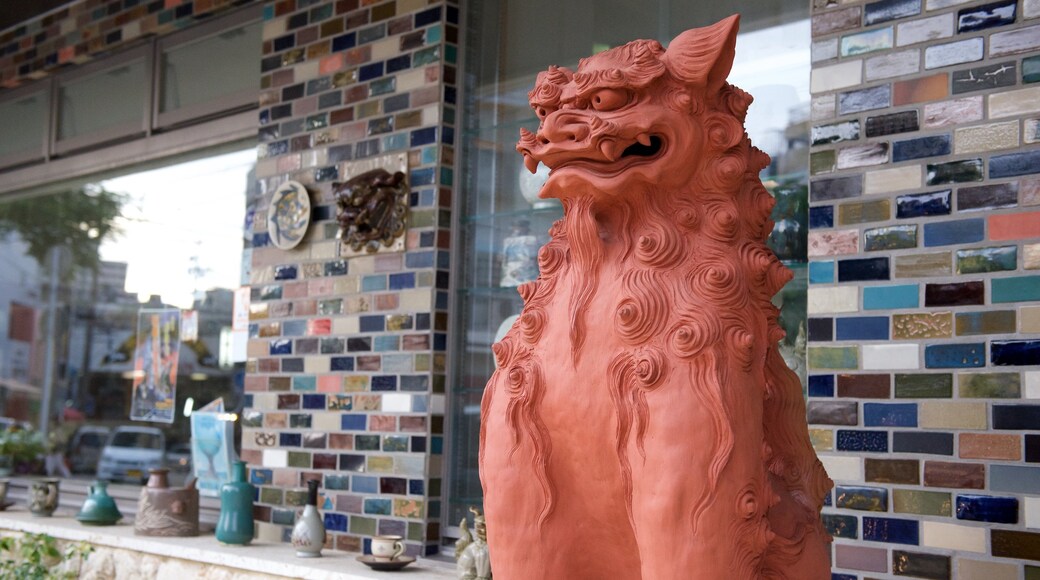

left=0, top=502, right=457, bottom=580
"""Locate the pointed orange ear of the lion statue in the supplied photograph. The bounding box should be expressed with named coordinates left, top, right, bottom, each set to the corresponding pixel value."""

left=665, top=15, right=740, bottom=95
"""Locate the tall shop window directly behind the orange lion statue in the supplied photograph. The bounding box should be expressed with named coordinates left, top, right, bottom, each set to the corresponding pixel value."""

left=445, top=0, right=810, bottom=525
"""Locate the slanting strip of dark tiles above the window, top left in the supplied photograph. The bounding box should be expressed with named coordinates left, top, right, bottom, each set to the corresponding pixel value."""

left=0, top=0, right=241, bottom=88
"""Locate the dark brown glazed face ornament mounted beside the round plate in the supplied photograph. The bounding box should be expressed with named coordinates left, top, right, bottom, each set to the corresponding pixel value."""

left=332, top=169, right=410, bottom=254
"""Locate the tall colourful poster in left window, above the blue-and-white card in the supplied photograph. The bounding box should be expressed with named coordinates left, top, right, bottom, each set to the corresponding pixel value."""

left=130, top=309, right=181, bottom=423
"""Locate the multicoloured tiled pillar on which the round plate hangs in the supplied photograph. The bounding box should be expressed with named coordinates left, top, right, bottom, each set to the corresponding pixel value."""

left=242, top=0, right=459, bottom=555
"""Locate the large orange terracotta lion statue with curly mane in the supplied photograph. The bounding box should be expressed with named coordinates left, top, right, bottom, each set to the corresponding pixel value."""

left=479, top=16, right=832, bottom=580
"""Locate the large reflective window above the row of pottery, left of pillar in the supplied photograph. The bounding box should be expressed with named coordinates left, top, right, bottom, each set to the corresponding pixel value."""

left=0, top=150, right=256, bottom=482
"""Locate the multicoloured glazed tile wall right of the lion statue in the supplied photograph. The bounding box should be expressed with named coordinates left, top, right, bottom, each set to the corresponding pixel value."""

left=808, top=0, right=1040, bottom=580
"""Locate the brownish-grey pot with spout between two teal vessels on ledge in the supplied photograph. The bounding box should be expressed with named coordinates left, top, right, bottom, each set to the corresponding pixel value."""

left=133, top=469, right=199, bottom=537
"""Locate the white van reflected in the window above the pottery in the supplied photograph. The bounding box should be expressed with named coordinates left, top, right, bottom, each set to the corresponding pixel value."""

left=98, top=426, right=166, bottom=483
